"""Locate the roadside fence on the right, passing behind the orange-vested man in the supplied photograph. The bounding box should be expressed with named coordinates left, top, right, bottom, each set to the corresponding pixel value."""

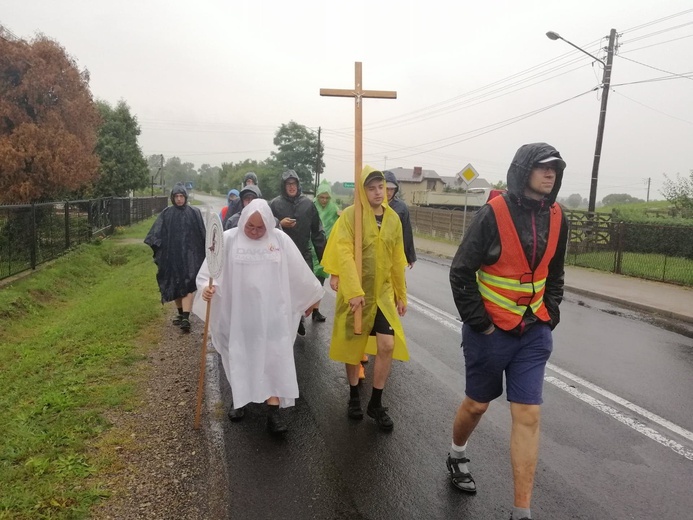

left=409, top=206, right=693, bottom=286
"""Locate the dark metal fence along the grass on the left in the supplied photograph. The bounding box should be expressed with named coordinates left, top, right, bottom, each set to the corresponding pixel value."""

left=0, top=196, right=168, bottom=280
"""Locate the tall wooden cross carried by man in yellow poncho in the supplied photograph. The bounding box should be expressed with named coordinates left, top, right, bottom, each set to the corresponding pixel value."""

left=320, top=61, right=397, bottom=334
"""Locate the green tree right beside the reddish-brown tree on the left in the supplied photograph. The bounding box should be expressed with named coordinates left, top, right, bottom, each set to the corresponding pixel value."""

left=94, top=101, right=150, bottom=197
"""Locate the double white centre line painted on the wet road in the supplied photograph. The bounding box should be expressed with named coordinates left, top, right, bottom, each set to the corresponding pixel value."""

left=407, top=295, right=693, bottom=460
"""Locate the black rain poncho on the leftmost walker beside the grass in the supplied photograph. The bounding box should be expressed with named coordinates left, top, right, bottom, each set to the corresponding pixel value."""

left=144, top=184, right=205, bottom=303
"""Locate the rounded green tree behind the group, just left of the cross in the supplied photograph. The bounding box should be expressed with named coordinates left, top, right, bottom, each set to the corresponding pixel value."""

left=272, top=121, right=325, bottom=190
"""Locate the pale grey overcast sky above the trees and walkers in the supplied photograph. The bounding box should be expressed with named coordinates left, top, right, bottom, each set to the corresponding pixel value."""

left=0, top=0, right=693, bottom=200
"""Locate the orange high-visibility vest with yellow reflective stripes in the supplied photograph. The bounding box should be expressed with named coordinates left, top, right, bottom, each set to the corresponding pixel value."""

left=477, top=197, right=562, bottom=330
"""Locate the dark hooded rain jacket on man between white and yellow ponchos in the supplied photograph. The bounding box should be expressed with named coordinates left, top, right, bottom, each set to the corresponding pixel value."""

left=270, top=170, right=327, bottom=271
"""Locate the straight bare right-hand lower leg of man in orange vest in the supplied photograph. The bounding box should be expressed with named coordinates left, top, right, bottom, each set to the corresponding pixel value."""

left=510, top=403, right=541, bottom=509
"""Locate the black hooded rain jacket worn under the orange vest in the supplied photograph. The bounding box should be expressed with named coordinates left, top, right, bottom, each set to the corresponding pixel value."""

left=450, top=143, right=568, bottom=334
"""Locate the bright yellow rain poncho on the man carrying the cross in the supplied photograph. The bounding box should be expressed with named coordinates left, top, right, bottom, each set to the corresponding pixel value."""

left=322, top=166, right=409, bottom=365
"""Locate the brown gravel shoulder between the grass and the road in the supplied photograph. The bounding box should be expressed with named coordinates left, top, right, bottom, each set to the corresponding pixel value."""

left=92, top=310, right=227, bottom=520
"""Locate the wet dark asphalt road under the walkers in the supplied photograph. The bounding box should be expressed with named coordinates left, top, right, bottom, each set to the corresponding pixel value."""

left=193, top=194, right=693, bottom=520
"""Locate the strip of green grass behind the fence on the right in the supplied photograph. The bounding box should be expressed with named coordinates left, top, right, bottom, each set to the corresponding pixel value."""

left=566, top=251, right=693, bottom=286
